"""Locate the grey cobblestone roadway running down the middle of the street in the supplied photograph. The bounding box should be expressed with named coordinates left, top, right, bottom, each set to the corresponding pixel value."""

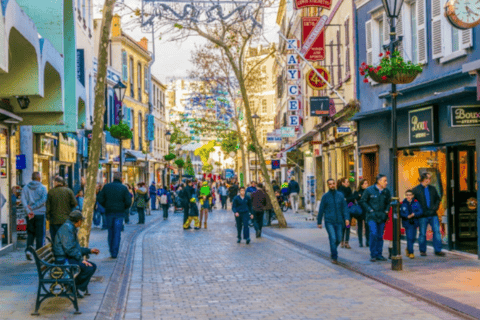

left=125, top=210, right=462, bottom=320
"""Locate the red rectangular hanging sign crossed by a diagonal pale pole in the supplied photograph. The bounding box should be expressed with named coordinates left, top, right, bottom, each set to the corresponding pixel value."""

left=300, top=16, right=328, bottom=61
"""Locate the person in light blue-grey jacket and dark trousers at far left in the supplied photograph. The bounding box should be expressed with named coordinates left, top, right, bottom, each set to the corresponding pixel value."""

left=21, top=172, right=47, bottom=260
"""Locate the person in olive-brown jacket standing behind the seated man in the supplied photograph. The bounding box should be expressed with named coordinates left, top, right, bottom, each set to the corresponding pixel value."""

left=46, top=176, right=78, bottom=243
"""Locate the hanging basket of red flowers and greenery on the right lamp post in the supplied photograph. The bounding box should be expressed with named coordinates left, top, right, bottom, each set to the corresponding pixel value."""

left=360, top=51, right=422, bottom=84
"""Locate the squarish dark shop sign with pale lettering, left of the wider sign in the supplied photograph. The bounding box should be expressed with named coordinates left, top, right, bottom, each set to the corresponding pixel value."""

left=408, top=107, right=435, bottom=145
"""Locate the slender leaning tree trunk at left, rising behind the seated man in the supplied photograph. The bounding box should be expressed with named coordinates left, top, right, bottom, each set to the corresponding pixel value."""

left=78, top=0, right=117, bottom=247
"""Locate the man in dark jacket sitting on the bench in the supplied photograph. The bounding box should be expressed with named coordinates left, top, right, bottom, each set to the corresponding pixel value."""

left=53, top=210, right=100, bottom=298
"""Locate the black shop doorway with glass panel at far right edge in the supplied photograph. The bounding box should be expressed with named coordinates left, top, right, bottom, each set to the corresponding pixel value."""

left=450, top=146, right=478, bottom=254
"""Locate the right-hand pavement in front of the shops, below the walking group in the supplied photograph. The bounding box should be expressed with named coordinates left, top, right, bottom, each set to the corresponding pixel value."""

left=267, top=211, right=480, bottom=318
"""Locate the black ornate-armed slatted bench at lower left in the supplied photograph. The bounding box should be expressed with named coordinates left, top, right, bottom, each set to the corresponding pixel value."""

left=27, top=243, right=81, bottom=316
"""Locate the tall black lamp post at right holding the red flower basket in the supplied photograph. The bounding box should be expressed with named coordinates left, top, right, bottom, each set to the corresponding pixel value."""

left=382, top=0, right=403, bottom=271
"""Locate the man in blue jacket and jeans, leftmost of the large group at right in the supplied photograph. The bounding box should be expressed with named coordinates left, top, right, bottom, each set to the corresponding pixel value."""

left=317, top=179, right=350, bottom=264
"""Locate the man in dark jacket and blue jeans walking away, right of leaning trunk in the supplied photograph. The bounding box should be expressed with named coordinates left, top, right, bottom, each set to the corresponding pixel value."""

left=97, top=172, right=132, bottom=259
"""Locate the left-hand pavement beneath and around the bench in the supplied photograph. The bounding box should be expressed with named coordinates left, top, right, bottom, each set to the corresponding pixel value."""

left=0, top=211, right=161, bottom=320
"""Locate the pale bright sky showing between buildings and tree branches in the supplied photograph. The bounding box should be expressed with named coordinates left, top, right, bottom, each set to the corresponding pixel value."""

left=94, top=0, right=279, bottom=83
